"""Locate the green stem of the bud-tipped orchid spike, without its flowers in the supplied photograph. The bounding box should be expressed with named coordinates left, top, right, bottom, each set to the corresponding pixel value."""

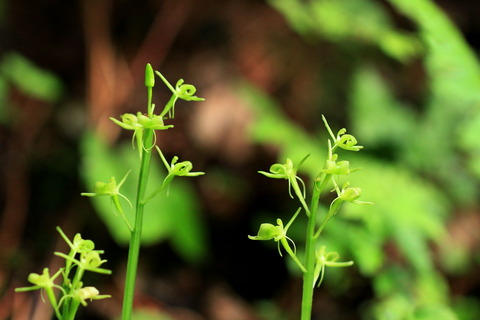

left=122, top=130, right=155, bottom=320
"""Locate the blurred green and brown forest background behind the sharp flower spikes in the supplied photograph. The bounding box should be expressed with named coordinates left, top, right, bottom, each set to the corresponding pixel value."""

left=0, top=0, right=480, bottom=320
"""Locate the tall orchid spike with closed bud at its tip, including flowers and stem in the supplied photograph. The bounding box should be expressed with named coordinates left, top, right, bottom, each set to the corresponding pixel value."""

left=88, top=64, right=204, bottom=320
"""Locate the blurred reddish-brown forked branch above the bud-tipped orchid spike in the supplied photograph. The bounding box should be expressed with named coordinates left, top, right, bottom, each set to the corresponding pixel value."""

left=83, top=0, right=191, bottom=141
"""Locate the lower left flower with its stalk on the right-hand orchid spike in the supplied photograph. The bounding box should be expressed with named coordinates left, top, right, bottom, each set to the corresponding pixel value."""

left=248, top=208, right=307, bottom=272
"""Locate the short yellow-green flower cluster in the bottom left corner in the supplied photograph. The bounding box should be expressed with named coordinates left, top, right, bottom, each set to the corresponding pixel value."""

left=15, top=227, right=112, bottom=320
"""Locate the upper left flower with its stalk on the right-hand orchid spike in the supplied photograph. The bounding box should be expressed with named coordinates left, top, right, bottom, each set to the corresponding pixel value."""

left=258, top=154, right=310, bottom=216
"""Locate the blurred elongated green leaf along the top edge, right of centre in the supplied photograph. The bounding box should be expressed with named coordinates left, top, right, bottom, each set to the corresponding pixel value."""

left=269, top=0, right=423, bottom=61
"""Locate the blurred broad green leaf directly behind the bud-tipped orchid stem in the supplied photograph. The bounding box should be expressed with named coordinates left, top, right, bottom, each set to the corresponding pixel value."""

left=82, top=133, right=206, bottom=262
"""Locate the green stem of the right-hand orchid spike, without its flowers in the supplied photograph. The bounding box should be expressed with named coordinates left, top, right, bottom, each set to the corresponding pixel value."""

left=300, top=173, right=330, bottom=320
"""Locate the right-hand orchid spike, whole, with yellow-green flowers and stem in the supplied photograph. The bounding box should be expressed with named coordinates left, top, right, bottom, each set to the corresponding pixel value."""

left=248, top=116, right=371, bottom=320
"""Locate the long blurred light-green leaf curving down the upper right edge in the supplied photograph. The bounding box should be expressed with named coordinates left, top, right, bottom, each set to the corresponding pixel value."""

left=390, top=0, right=480, bottom=203
